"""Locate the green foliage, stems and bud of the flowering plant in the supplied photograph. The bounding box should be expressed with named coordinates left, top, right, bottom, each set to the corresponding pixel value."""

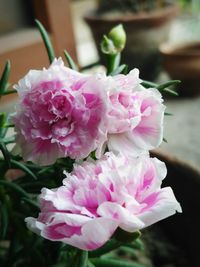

left=0, top=21, right=179, bottom=267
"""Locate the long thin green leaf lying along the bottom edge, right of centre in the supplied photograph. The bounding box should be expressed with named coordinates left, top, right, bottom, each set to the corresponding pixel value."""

left=91, top=258, right=144, bottom=267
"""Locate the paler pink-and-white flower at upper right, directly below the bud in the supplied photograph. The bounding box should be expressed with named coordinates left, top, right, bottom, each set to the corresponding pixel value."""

left=104, top=69, right=165, bottom=156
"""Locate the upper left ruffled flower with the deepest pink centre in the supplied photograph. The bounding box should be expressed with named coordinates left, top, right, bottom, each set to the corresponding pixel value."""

left=13, top=59, right=106, bottom=165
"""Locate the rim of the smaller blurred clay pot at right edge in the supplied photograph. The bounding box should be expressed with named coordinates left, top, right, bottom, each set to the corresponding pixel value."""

left=159, top=41, right=200, bottom=57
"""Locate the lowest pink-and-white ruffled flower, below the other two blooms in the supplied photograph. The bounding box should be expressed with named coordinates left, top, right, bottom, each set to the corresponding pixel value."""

left=26, top=153, right=181, bottom=250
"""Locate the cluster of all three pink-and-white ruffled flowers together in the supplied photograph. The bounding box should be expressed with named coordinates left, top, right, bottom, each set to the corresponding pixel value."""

left=13, top=59, right=181, bottom=250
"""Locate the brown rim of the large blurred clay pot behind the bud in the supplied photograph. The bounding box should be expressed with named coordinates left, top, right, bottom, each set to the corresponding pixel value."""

left=84, top=3, right=180, bottom=23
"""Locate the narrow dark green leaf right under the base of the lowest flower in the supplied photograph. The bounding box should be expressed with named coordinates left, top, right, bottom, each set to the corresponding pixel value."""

left=89, top=239, right=122, bottom=258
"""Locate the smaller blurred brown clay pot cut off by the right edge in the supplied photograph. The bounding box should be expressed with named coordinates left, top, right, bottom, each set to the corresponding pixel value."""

left=160, top=43, right=200, bottom=96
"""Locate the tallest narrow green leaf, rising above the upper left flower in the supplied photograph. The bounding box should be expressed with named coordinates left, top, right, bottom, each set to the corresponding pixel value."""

left=35, top=19, right=55, bottom=63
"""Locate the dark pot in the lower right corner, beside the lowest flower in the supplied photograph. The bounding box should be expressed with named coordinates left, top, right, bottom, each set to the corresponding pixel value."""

left=148, top=152, right=200, bottom=267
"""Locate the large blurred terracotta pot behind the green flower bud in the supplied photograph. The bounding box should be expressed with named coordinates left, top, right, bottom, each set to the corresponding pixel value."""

left=84, top=4, right=179, bottom=80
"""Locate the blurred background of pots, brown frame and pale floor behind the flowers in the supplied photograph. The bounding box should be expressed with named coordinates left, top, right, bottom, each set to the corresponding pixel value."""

left=0, top=0, right=200, bottom=171
